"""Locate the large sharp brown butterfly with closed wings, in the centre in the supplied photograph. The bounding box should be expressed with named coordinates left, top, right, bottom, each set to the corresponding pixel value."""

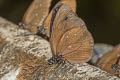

left=48, top=2, right=94, bottom=64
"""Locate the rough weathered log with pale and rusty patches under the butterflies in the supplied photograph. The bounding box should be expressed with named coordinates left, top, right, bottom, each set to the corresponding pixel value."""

left=0, top=18, right=120, bottom=80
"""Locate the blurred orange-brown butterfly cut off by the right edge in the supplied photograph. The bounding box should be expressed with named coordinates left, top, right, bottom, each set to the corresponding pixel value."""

left=98, top=45, right=120, bottom=75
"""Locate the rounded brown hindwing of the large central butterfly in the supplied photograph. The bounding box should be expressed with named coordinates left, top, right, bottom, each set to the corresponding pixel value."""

left=57, top=27, right=93, bottom=63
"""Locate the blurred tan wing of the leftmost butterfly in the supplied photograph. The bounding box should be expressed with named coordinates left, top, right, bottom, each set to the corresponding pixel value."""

left=21, top=0, right=51, bottom=33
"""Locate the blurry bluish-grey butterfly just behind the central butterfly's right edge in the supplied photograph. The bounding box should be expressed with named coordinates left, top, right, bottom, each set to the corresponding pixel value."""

left=90, top=43, right=113, bottom=65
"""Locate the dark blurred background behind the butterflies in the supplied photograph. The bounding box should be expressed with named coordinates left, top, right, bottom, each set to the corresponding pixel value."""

left=0, top=0, right=120, bottom=45
